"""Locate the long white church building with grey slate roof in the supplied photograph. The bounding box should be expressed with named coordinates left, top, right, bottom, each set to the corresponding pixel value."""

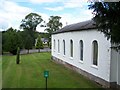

left=52, top=20, right=120, bottom=88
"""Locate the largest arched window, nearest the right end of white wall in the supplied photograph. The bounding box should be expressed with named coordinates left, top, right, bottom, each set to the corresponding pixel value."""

left=92, top=40, right=98, bottom=66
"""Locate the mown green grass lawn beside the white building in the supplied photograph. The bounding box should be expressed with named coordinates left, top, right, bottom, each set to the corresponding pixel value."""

left=2, top=53, right=100, bottom=88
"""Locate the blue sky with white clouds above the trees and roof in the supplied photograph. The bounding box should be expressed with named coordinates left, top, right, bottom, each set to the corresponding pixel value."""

left=0, top=0, right=93, bottom=32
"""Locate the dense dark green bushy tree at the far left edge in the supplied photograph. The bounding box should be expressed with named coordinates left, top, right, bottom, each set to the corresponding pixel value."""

left=2, top=27, right=22, bottom=55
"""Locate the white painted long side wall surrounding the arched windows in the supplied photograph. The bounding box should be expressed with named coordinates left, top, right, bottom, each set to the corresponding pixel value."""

left=52, top=30, right=111, bottom=82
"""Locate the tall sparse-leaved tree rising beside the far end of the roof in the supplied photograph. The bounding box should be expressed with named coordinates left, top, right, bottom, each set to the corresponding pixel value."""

left=45, top=16, right=62, bottom=45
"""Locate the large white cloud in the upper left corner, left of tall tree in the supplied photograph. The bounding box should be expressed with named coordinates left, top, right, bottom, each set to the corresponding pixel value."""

left=0, top=0, right=33, bottom=29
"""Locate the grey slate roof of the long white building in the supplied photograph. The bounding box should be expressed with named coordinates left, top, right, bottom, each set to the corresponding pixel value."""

left=53, top=20, right=96, bottom=34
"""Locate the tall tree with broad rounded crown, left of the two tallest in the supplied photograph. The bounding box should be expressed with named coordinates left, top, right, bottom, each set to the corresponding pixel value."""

left=20, top=13, right=43, bottom=45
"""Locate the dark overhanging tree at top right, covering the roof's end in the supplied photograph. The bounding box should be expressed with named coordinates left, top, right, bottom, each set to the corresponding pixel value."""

left=89, top=2, right=120, bottom=48
